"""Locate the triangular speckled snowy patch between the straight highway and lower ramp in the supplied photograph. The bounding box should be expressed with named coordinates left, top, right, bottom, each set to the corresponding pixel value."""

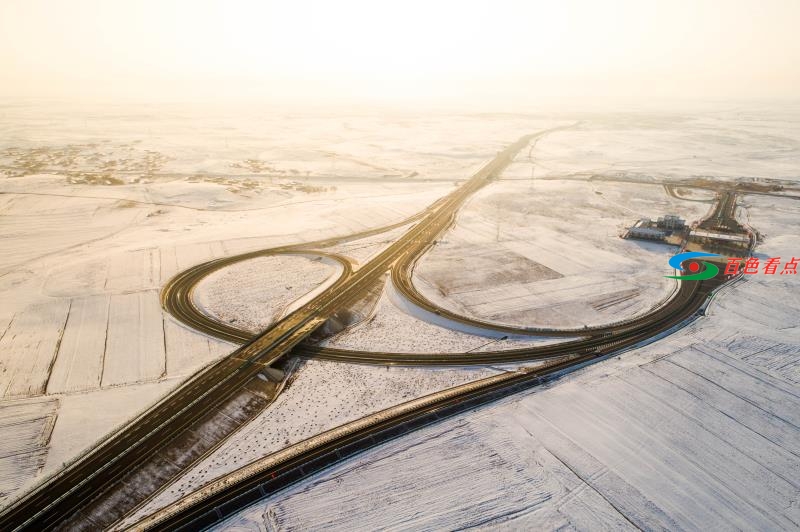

left=121, top=360, right=498, bottom=523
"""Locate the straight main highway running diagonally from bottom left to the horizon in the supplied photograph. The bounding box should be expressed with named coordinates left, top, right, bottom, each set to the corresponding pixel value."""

left=0, top=127, right=564, bottom=531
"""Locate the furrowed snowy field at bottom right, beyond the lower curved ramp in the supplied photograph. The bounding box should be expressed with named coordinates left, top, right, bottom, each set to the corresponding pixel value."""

left=211, top=196, right=800, bottom=530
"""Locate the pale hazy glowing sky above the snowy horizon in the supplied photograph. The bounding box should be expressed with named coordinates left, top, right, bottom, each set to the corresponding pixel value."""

left=0, top=0, right=800, bottom=107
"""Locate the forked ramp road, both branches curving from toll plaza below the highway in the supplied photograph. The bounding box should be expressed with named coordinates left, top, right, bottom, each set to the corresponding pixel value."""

left=133, top=274, right=721, bottom=531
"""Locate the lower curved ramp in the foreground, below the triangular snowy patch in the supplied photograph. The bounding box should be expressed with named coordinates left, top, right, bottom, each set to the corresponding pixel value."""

left=130, top=355, right=597, bottom=532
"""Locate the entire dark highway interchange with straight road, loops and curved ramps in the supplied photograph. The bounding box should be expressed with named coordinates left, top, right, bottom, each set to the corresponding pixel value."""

left=0, top=130, right=752, bottom=530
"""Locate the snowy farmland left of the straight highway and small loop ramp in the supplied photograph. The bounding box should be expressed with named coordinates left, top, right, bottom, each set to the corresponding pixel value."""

left=0, top=106, right=536, bottom=504
